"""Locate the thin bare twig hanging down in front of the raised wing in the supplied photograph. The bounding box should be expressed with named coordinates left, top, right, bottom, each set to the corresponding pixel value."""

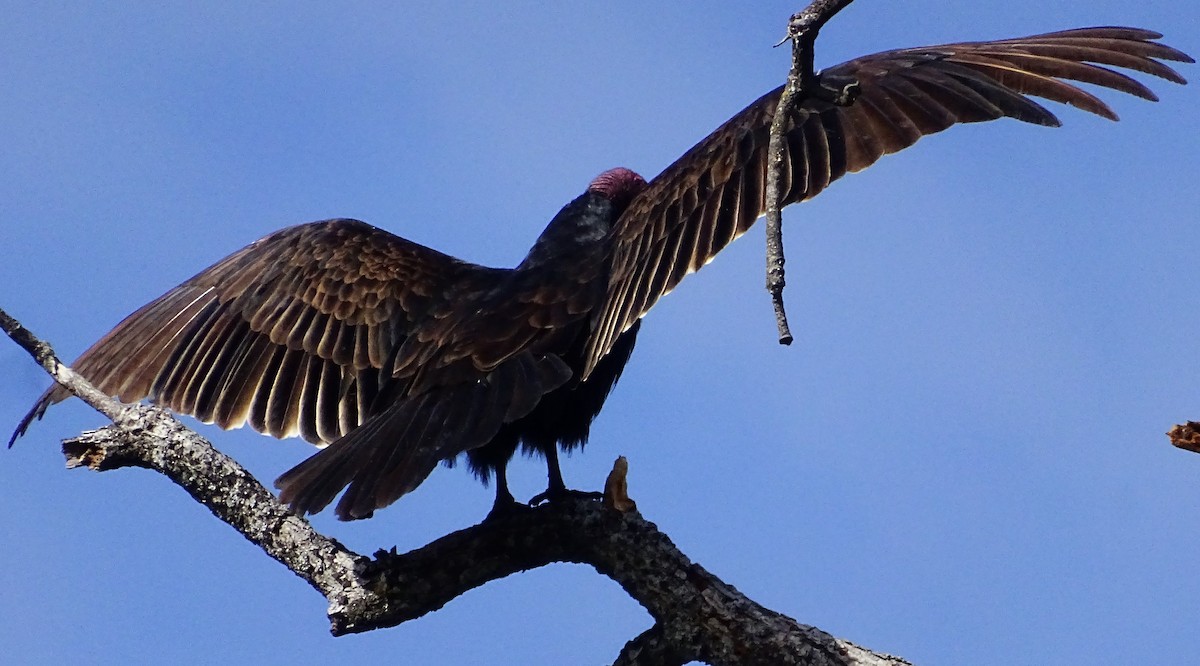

left=766, top=0, right=853, bottom=344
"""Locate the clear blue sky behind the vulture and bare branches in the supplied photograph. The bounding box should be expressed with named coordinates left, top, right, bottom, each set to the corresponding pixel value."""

left=0, top=0, right=1200, bottom=665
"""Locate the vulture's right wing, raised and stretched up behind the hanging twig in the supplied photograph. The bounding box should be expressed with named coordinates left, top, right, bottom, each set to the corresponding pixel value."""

left=583, top=28, right=1192, bottom=377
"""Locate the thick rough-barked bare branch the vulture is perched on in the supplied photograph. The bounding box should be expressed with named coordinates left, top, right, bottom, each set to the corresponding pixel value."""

left=0, top=303, right=906, bottom=665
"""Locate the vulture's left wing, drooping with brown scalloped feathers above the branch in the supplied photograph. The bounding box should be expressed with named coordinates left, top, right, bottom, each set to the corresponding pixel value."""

left=13, top=220, right=506, bottom=444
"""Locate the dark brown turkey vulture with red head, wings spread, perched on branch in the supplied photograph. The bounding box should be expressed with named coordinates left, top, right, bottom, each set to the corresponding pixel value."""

left=13, top=28, right=1192, bottom=520
